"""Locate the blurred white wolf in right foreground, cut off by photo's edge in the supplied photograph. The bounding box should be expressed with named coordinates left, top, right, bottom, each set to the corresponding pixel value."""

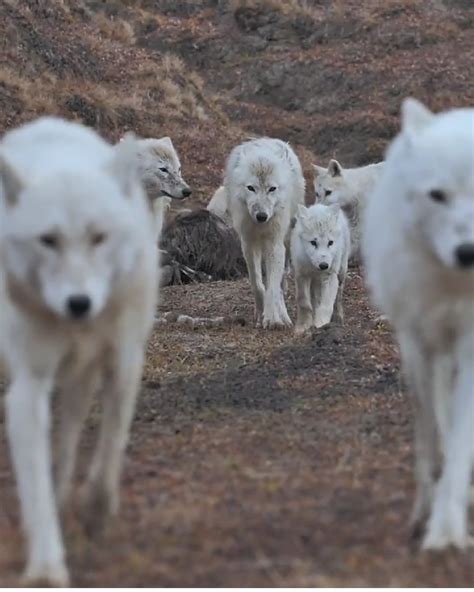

left=363, top=99, right=474, bottom=549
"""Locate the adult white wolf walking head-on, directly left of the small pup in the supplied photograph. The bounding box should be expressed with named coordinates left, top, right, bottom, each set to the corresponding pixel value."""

left=224, top=138, right=305, bottom=328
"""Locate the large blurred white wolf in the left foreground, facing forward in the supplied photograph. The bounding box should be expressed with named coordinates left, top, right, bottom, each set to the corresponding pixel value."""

left=0, top=118, right=158, bottom=585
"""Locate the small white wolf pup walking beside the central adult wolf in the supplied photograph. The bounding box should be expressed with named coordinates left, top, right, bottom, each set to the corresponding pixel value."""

left=291, top=204, right=351, bottom=332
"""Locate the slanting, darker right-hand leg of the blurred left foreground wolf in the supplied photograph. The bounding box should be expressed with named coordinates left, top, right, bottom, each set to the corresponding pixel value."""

left=83, top=341, right=144, bottom=533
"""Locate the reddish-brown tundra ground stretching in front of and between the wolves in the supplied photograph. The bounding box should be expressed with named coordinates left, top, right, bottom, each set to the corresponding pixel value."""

left=0, top=273, right=474, bottom=586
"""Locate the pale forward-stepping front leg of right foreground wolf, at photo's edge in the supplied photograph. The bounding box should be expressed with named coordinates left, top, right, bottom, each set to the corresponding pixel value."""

left=423, top=335, right=474, bottom=549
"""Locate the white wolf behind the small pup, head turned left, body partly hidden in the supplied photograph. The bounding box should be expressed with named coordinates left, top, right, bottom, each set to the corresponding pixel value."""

left=313, top=159, right=384, bottom=262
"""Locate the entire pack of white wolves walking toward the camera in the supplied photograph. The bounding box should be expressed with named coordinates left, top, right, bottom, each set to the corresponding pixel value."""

left=0, top=98, right=474, bottom=586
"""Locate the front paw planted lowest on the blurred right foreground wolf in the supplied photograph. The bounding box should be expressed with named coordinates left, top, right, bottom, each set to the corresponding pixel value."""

left=422, top=502, right=473, bottom=551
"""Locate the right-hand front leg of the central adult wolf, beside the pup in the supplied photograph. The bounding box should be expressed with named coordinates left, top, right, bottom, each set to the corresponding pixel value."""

left=263, top=241, right=293, bottom=329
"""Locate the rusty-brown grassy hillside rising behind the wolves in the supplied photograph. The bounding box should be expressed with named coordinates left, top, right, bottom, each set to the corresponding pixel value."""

left=0, top=0, right=474, bottom=203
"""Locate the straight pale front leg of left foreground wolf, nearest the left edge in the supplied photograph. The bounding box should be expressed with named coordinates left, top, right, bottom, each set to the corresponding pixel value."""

left=6, top=370, right=69, bottom=586
